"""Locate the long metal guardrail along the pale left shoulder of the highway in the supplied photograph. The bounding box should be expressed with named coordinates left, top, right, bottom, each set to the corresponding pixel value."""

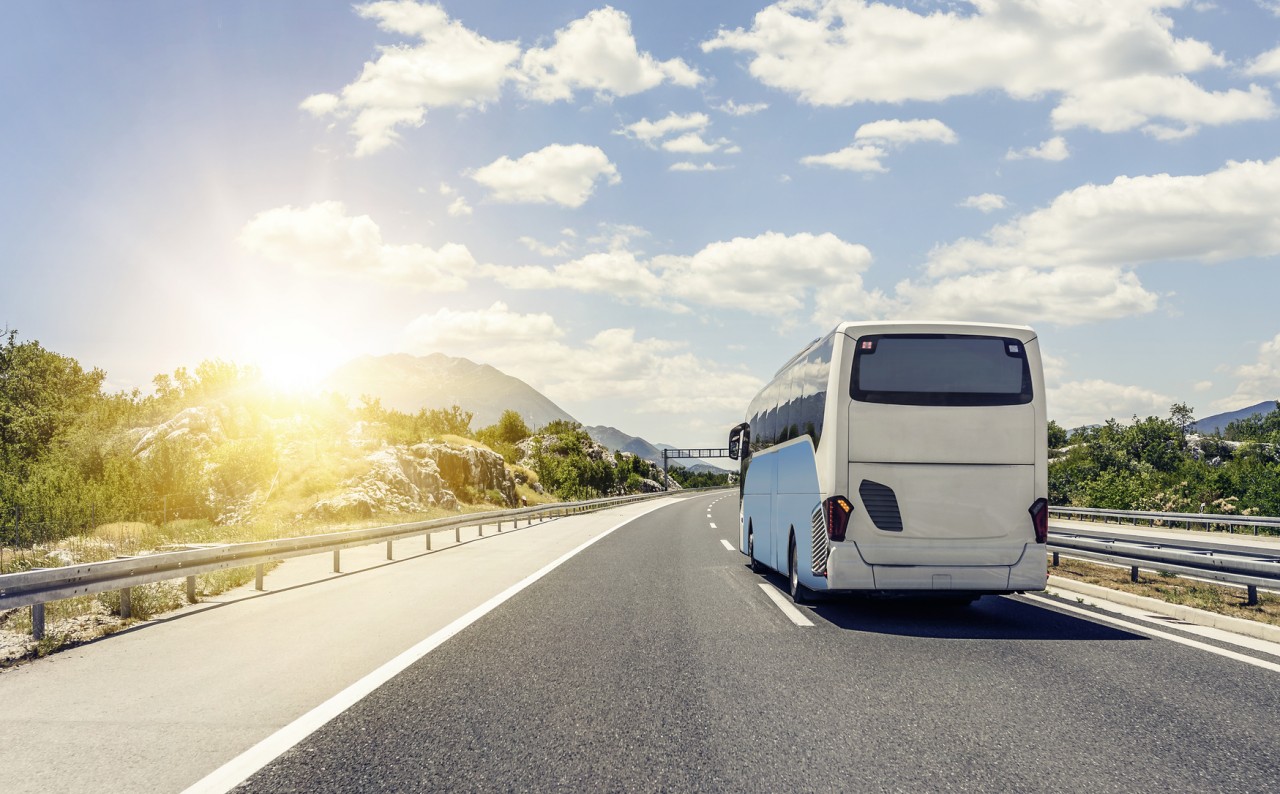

left=0, top=489, right=695, bottom=639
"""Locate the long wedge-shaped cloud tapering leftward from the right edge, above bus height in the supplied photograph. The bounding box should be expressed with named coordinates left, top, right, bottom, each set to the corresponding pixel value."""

left=929, top=158, right=1280, bottom=275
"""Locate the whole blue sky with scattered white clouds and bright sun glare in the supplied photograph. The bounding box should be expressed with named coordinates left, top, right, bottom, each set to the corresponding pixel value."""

left=0, top=0, right=1280, bottom=447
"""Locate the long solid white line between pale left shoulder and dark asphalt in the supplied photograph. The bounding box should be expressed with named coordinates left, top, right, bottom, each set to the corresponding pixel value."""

left=183, top=505, right=666, bottom=794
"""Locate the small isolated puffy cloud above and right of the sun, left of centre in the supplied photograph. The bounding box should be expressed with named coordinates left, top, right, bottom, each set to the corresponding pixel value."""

left=468, top=143, right=622, bottom=207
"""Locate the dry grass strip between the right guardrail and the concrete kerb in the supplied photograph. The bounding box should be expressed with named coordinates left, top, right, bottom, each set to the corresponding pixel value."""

left=1048, top=557, right=1280, bottom=626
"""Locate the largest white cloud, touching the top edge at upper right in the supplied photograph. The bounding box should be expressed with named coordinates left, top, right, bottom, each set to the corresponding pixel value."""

left=701, top=0, right=1276, bottom=136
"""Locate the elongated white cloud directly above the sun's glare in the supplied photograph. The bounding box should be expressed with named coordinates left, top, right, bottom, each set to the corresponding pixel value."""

left=239, top=201, right=476, bottom=292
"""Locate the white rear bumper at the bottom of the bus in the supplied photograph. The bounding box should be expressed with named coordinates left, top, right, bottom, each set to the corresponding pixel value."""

left=827, top=542, right=1047, bottom=593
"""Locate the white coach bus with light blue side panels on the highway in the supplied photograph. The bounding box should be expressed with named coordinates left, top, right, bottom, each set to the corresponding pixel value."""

left=730, top=323, right=1048, bottom=603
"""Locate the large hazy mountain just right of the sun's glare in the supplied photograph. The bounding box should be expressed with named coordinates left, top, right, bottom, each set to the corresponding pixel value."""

left=324, top=353, right=573, bottom=429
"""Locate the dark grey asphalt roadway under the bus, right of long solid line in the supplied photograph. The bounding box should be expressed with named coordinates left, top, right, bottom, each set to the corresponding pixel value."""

left=242, top=492, right=1280, bottom=791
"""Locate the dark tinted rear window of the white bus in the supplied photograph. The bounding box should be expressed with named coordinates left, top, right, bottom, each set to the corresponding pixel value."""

left=850, top=334, right=1032, bottom=406
